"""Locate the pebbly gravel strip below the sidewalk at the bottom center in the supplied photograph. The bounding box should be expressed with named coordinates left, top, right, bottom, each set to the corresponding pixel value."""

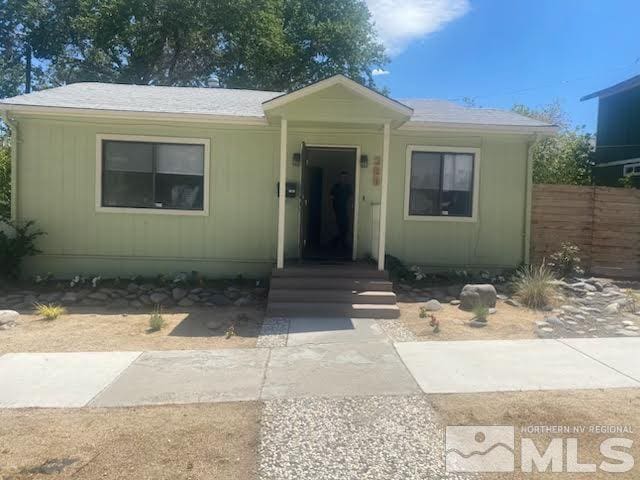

left=259, top=395, right=474, bottom=480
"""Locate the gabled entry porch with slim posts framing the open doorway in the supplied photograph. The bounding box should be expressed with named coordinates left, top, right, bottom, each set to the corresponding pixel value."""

left=263, top=76, right=412, bottom=273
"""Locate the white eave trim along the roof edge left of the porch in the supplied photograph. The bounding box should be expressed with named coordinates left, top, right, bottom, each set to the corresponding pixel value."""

left=0, top=103, right=269, bottom=126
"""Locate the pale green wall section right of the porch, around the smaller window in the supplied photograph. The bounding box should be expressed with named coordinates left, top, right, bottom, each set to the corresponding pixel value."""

left=386, top=129, right=527, bottom=268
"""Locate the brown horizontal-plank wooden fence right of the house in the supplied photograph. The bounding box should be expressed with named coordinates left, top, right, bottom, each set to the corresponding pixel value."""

left=531, top=185, right=640, bottom=278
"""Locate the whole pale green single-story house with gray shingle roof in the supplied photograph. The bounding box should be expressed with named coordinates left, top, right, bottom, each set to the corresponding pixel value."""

left=0, top=75, right=555, bottom=316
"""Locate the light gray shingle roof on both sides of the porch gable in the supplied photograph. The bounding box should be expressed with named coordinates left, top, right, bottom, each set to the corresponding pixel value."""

left=0, top=83, right=549, bottom=127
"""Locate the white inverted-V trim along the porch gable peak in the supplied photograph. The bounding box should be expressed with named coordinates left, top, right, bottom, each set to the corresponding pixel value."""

left=262, top=75, right=413, bottom=117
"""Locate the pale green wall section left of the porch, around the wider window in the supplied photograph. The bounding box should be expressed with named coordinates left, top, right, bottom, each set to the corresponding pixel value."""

left=18, top=114, right=279, bottom=276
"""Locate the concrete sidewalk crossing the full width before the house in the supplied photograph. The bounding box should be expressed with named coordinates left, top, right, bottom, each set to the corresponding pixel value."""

left=0, top=336, right=640, bottom=408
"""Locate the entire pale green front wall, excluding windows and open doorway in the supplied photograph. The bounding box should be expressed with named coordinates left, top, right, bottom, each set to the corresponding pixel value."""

left=13, top=113, right=527, bottom=276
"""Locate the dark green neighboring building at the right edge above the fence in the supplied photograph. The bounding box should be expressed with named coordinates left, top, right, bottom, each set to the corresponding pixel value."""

left=581, top=75, right=640, bottom=187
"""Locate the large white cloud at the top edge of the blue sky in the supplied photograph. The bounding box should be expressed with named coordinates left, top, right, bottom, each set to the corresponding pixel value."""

left=366, top=0, right=470, bottom=55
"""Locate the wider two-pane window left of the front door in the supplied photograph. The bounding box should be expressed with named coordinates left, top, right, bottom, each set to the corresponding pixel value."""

left=100, top=139, right=205, bottom=211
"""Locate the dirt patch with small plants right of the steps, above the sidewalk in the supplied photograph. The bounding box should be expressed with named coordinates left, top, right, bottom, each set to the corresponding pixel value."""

left=398, top=300, right=548, bottom=340
